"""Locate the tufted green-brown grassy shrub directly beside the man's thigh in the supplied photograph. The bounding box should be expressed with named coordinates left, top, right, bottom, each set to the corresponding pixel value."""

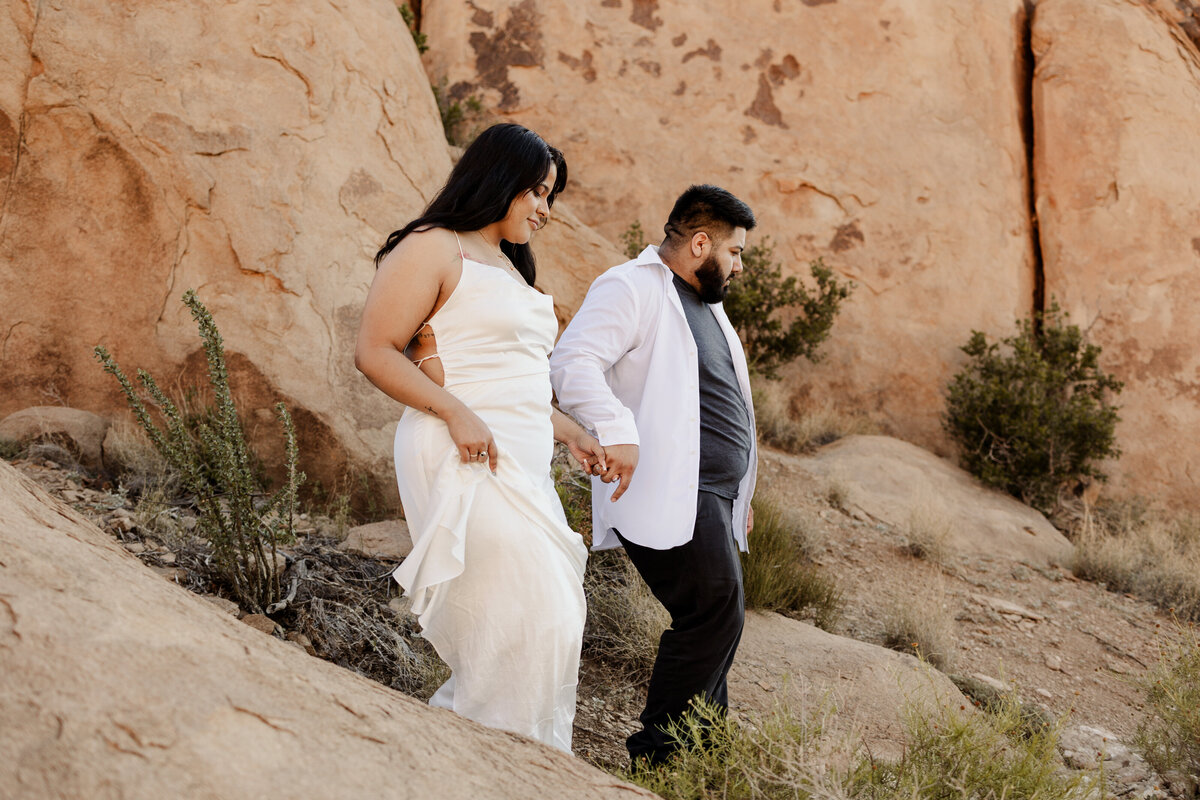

left=742, top=494, right=842, bottom=631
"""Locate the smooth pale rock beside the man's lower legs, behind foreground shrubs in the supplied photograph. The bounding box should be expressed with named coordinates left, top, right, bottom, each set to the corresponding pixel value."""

left=728, top=612, right=973, bottom=758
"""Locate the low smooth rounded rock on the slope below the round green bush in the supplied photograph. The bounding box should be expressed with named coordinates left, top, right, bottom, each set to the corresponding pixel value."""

left=762, top=437, right=1072, bottom=565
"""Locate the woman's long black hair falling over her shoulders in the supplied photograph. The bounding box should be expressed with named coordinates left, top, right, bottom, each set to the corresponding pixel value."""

left=376, top=122, right=566, bottom=285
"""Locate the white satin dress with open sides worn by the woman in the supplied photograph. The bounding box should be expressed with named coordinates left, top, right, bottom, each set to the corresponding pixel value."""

left=394, top=247, right=587, bottom=752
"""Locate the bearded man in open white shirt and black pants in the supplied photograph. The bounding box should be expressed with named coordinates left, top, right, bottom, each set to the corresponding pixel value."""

left=550, top=186, right=757, bottom=763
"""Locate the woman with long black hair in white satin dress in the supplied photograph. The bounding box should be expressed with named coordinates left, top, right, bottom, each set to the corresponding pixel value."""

left=355, top=124, right=604, bottom=752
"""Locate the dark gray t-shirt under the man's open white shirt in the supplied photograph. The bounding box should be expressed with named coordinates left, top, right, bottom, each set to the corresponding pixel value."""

left=674, top=275, right=754, bottom=499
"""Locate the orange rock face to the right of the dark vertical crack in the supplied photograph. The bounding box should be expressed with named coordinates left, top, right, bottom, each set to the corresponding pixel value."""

left=1033, top=0, right=1200, bottom=506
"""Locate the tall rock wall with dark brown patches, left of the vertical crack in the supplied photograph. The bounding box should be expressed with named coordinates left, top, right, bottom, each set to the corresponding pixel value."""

left=421, top=0, right=1034, bottom=445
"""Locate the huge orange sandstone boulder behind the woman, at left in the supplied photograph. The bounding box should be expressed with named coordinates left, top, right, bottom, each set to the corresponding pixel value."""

left=0, top=0, right=617, bottom=506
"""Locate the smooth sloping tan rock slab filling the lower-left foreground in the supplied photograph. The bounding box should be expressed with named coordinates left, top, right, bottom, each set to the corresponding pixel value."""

left=0, top=455, right=653, bottom=800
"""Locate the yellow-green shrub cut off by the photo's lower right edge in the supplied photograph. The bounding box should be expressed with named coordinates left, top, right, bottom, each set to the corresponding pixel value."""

left=1138, top=628, right=1200, bottom=798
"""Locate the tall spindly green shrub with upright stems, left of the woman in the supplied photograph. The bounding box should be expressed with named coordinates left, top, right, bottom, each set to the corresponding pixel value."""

left=95, top=289, right=304, bottom=612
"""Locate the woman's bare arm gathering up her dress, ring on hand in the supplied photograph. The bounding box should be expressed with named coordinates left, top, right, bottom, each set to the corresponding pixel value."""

left=354, top=236, right=496, bottom=470
